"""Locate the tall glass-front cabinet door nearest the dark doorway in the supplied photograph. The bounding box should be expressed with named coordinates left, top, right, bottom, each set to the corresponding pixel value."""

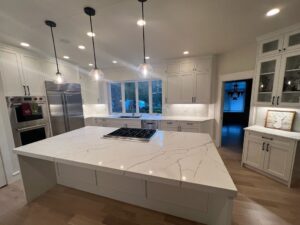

left=256, top=56, right=281, bottom=106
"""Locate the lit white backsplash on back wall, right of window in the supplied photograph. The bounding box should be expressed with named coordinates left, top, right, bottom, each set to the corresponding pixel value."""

left=163, top=104, right=209, bottom=117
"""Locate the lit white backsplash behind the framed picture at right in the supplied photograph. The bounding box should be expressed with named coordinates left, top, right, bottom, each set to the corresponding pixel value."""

left=255, top=107, right=300, bottom=132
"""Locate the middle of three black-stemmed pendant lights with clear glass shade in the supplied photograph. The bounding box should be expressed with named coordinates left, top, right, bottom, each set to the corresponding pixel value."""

left=84, top=7, right=104, bottom=80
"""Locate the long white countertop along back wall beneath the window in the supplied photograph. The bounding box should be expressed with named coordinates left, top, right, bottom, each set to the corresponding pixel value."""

left=84, top=115, right=212, bottom=122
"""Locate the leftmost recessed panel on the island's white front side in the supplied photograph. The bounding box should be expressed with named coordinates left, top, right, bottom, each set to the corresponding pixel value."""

left=57, top=163, right=96, bottom=185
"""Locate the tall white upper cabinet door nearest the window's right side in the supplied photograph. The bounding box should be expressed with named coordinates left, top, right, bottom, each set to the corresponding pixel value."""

left=167, top=76, right=181, bottom=104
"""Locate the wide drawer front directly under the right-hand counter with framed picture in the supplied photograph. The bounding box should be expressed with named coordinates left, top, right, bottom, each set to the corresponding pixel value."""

left=247, top=131, right=295, bottom=147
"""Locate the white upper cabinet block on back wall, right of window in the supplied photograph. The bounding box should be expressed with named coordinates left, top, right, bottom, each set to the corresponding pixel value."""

left=166, top=57, right=213, bottom=104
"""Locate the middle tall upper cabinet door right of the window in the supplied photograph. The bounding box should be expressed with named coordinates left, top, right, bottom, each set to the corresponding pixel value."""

left=180, top=74, right=195, bottom=103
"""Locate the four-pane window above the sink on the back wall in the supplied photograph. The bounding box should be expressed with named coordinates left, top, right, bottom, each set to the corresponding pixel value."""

left=110, top=80, right=162, bottom=113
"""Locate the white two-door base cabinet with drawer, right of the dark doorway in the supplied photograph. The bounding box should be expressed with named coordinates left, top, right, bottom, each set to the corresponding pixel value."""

left=242, top=130, right=299, bottom=186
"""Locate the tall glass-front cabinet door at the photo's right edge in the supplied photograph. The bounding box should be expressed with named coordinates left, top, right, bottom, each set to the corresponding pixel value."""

left=277, top=51, right=300, bottom=107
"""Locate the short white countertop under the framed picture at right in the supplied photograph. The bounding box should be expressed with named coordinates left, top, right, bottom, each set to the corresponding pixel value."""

left=245, top=125, right=300, bottom=141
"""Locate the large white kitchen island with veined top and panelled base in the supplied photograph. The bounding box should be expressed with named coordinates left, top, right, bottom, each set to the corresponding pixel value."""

left=14, top=127, right=237, bottom=225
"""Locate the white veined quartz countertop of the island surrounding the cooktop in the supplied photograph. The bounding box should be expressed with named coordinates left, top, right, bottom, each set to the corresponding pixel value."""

left=14, top=127, right=237, bottom=197
